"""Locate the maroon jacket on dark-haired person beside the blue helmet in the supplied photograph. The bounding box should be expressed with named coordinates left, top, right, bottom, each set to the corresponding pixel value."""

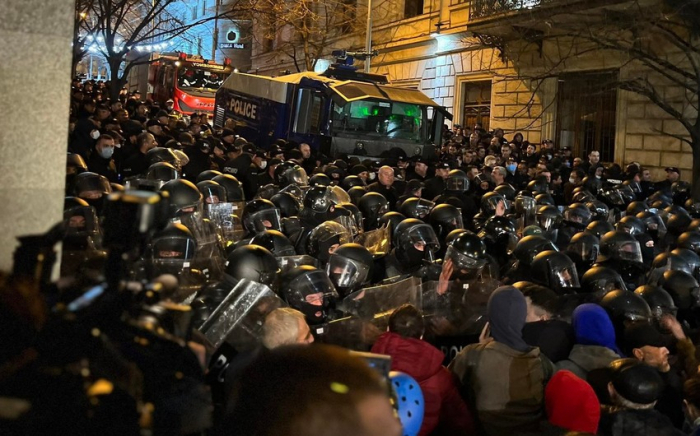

left=372, top=332, right=476, bottom=436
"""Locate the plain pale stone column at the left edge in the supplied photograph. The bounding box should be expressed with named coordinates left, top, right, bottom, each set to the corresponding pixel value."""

left=0, top=0, right=75, bottom=271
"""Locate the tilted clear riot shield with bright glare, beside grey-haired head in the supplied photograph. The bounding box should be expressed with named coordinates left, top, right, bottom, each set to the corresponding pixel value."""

left=199, top=279, right=286, bottom=351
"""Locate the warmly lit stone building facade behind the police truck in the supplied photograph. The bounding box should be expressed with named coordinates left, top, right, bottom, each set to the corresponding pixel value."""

left=252, top=0, right=697, bottom=180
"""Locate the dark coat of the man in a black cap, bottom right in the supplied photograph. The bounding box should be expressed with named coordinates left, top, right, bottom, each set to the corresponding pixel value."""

left=598, top=408, right=684, bottom=436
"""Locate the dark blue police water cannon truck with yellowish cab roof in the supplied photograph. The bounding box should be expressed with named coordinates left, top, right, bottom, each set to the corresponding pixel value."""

left=214, top=52, right=452, bottom=156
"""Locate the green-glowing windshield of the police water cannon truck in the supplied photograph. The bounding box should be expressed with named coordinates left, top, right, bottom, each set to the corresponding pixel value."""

left=333, top=100, right=427, bottom=142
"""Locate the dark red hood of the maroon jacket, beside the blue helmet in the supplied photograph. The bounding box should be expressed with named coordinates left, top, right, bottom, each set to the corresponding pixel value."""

left=372, top=332, right=445, bottom=382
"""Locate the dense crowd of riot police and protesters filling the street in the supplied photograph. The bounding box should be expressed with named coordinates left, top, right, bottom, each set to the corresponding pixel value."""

left=0, top=81, right=700, bottom=436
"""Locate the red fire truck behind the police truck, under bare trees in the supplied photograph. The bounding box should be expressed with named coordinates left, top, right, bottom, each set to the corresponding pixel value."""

left=148, top=52, right=233, bottom=116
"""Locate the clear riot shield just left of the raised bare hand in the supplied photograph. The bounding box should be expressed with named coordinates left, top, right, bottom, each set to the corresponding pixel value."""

left=338, top=277, right=422, bottom=320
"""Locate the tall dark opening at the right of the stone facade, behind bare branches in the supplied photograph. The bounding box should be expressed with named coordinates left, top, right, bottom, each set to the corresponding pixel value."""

left=556, top=71, right=618, bottom=162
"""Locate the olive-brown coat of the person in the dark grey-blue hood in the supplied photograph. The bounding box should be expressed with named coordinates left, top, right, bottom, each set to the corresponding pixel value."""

left=449, top=341, right=554, bottom=436
